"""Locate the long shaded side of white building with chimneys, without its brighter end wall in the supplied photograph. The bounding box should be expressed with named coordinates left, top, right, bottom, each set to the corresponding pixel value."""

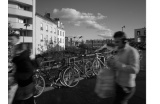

left=35, top=13, right=57, bottom=54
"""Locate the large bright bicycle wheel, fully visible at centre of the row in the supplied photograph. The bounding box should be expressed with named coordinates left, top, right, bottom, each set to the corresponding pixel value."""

left=63, top=67, right=80, bottom=87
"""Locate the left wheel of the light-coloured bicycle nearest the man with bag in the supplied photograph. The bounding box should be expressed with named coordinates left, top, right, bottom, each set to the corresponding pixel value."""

left=92, top=60, right=101, bottom=75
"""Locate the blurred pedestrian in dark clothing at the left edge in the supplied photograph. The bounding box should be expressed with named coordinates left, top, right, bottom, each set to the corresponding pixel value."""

left=9, top=33, right=35, bottom=104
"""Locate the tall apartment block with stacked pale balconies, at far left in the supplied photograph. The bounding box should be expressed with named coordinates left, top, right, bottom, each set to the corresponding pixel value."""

left=8, top=0, right=36, bottom=55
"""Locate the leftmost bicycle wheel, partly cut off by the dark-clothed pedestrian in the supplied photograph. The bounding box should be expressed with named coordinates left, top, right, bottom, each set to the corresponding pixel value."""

left=33, top=76, right=45, bottom=98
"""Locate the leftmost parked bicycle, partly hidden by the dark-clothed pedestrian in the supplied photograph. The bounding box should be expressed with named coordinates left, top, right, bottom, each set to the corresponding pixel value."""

left=33, top=60, right=65, bottom=97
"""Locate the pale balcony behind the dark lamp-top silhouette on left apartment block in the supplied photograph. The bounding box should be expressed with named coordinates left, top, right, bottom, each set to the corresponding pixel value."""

left=11, top=22, right=33, bottom=30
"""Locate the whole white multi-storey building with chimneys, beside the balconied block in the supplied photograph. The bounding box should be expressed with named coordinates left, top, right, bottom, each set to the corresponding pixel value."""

left=36, top=13, right=65, bottom=54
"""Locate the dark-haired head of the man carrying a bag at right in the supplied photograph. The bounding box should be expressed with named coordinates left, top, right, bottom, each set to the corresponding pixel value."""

left=113, top=31, right=127, bottom=49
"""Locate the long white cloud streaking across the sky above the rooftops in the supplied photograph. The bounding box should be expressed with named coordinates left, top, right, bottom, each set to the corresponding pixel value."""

left=53, top=8, right=107, bottom=30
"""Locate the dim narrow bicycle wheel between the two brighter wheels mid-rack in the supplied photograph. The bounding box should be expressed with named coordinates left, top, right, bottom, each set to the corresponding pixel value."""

left=85, top=61, right=93, bottom=77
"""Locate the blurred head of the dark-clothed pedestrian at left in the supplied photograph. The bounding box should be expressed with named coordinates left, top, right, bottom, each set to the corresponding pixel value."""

left=8, top=32, right=19, bottom=45
